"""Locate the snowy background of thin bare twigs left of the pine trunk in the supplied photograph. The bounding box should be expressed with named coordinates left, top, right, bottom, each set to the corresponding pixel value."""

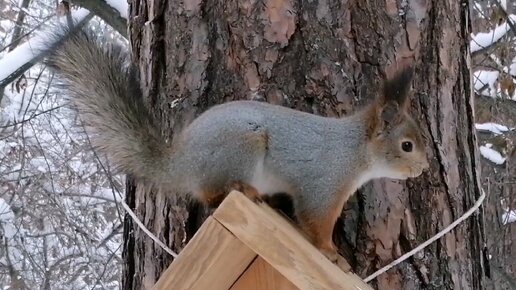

left=0, top=0, right=127, bottom=289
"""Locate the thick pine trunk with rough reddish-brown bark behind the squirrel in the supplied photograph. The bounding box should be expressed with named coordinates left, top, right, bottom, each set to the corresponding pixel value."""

left=124, top=0, right=485, bottom=289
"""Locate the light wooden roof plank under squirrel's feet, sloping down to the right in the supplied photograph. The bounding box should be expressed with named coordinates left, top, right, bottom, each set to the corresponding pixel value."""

left=213, top=192, right=372, bottom=290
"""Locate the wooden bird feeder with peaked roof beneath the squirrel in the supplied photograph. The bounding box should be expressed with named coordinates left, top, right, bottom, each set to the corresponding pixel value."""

left=153, top=191, right=372, bottom=290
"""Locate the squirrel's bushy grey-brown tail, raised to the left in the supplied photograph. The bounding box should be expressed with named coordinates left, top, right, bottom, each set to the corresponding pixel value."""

left=47, top=30, right=170, bottom=182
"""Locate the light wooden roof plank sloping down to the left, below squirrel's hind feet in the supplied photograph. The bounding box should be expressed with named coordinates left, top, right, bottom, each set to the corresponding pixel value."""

left=152, top=217, right=256, bottom=290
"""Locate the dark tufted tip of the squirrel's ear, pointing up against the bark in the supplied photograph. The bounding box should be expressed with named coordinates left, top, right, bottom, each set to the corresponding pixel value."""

left=381, top=66, right=414, bottom=109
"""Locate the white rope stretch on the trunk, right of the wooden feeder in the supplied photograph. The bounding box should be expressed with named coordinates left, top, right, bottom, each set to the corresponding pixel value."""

left=364, top=190, right=486, bottom=283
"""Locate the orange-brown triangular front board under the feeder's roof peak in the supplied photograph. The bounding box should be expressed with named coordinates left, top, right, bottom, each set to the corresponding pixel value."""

left=230, top=257, right=299, bottom=290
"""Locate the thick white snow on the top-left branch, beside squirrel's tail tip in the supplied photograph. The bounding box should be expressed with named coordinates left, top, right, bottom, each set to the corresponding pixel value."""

left=0, top=9, right=93, bottom=87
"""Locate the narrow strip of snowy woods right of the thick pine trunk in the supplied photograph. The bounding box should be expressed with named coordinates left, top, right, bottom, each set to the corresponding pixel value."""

left=471, top=0, right=516, bottom=290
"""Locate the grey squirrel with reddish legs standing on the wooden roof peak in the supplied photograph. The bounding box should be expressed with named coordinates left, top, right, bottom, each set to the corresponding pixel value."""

left=46, top=30, right=429, bottom=263
